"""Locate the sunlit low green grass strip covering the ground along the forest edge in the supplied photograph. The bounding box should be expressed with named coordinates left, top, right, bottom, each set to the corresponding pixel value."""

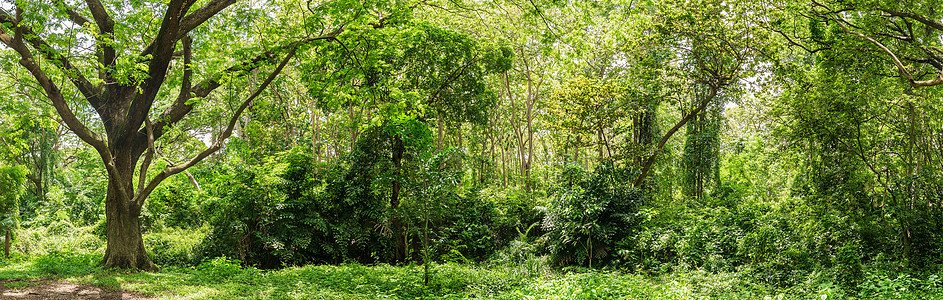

left=0, top=253, right=943, bottom=300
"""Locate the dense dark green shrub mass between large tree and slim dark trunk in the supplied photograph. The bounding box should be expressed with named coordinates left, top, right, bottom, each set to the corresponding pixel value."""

left=201, top=143, right=389, bottom=268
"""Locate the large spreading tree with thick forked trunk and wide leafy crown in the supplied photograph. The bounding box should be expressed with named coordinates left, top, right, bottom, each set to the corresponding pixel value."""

left=0, top=0, right=394, bottom=270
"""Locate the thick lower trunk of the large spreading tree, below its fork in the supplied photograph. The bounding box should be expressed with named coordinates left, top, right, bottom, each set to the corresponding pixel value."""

left=102, top=184, right=157, bottom=271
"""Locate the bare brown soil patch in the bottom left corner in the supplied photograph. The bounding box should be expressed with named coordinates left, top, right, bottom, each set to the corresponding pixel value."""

left=0, top=279, right=152, bottom=300
